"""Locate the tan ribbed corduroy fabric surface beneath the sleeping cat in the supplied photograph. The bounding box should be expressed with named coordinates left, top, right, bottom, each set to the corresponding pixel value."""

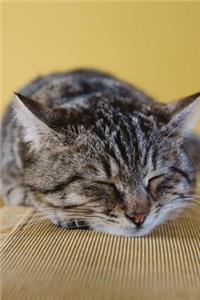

left=1, top=205, right=200, bottom=300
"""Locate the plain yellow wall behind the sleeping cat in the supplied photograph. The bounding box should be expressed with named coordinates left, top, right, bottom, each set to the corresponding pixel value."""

left=1, top=1, right=200, bottom=113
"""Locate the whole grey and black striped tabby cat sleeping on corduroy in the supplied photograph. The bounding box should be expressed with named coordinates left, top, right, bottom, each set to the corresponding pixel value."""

left=1, top=70, right=200, bottom=236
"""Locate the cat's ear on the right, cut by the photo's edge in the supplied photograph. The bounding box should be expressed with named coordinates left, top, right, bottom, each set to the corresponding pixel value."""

left=166, top=93, right=200, bottom=133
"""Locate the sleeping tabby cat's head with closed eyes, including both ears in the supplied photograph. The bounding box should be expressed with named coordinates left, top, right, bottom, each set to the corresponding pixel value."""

left=15, top=93, right=200, bottom=236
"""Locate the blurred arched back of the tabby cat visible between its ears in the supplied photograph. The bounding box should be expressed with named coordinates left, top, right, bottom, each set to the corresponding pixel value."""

left=11, top=69, right=151, bottom=107
